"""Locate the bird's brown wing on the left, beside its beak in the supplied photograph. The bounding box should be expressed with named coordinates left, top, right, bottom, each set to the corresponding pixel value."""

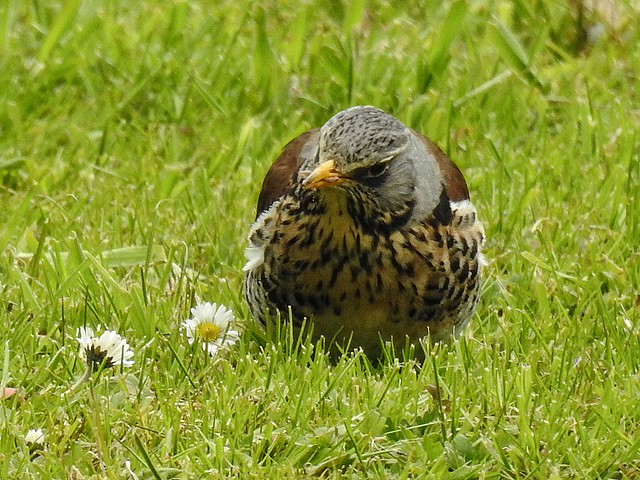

left=256, top=128, right=320, bottom=218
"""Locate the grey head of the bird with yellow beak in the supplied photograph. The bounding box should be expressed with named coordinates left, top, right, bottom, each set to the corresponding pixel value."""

left=303, top=106, right=443, bottom=229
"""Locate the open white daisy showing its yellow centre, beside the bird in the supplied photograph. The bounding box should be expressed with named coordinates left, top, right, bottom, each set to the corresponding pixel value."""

left=182, top=302, right=238, bottom=355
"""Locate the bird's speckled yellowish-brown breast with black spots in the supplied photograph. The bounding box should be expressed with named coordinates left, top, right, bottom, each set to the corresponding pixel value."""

left=245, top=192, right=482, bottom=355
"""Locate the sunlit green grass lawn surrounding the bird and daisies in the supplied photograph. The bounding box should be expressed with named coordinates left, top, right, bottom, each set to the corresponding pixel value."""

left=0, top=0, right=640, bottom=479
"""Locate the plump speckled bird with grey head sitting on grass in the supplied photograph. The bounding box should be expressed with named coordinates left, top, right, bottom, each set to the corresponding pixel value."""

left=243, top=105, right=486, bottom=359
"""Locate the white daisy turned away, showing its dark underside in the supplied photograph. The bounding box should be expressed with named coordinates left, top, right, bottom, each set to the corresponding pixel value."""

left=78, top=327, right=133, bottom=370
